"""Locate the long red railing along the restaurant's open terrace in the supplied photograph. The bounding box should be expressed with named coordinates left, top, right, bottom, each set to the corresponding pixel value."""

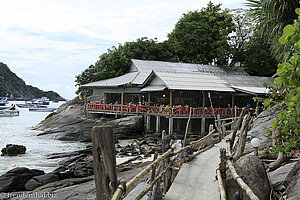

left=87, top=103, right=242, bottom=116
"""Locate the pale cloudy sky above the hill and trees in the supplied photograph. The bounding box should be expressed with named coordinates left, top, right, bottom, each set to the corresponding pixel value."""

left=0, top=0, right=245, bottom=99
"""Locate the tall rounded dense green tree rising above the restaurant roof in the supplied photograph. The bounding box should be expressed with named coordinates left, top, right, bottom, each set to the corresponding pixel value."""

left=168, top=2, right=235, bottom=66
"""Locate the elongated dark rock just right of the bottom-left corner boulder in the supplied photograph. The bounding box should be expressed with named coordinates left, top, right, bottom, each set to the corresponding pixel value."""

left=25, top=173, right=59, bottom=190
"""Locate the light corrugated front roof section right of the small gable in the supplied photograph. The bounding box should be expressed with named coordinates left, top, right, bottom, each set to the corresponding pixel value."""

left=154, top=71, right=235, bottom=92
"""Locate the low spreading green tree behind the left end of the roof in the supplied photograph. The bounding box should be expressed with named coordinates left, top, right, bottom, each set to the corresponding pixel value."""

left=75, top=37, right=171, bottom=93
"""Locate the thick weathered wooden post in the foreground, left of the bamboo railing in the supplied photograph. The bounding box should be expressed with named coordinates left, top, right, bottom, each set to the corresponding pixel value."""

left=92, top=126, right=117, bottom=200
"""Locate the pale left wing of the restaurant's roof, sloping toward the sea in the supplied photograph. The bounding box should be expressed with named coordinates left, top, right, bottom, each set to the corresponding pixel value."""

left=82, top=72, right=139, bottom=88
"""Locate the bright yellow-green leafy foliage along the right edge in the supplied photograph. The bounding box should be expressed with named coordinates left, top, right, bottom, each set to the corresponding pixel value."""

left=264, top=8, right=300, bottom=153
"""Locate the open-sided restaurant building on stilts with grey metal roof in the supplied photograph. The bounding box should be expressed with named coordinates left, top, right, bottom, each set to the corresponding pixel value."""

left=81, top=59, right=274, bottom=134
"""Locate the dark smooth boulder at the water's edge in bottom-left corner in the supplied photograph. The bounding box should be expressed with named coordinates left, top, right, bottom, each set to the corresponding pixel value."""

left=0, top=167, right=45, bottom=192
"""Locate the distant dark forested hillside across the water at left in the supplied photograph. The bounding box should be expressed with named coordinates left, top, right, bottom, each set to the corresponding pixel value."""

left=0, top=62, right=65, bottom=101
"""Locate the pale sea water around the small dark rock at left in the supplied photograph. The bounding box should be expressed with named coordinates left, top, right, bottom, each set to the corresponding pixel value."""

left=0, top=101, right=86, bottom=175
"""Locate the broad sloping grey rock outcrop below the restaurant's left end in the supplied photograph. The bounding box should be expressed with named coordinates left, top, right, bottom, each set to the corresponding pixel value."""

left=34, top=98, right=143, bottom=141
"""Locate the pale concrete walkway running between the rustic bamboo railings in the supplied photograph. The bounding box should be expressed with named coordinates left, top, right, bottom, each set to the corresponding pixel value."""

left=164, top=141, right=226, bottom=200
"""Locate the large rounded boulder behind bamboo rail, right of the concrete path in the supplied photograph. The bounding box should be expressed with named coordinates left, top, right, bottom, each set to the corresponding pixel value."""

left=226, top=155, right=271, bottom=199
